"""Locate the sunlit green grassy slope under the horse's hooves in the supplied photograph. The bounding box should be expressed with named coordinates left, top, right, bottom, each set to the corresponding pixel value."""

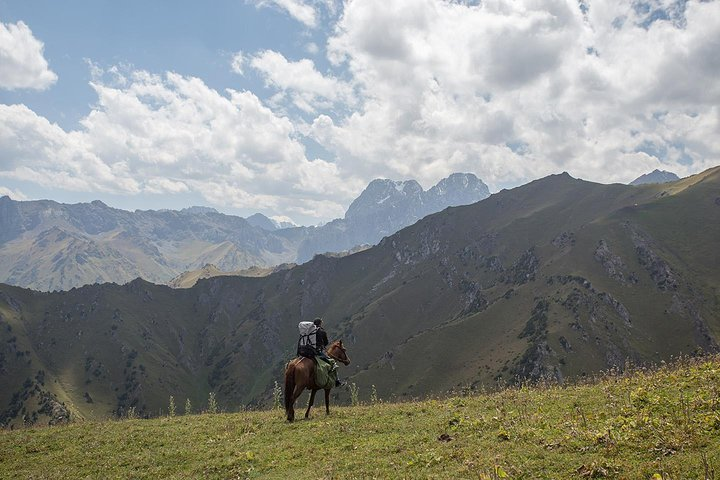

left=0, top=357, right=720, bottom=480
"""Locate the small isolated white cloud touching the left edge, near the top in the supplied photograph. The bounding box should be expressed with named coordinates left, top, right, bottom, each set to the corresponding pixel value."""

left=0, top=22, right=57, bottom=90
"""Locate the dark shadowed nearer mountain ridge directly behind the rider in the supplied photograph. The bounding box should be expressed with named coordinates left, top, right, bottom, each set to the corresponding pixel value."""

left=0, top=167, right=720, bottom=424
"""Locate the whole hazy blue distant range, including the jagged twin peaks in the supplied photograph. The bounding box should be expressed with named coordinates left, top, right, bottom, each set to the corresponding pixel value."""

left=0, top=174, right=489, bottom=291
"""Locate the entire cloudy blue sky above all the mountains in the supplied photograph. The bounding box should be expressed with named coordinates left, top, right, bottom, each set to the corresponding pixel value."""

left=0, top=0, right=720, bottom=225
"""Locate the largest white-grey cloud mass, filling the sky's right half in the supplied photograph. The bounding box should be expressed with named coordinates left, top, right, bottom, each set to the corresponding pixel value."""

left=308, top=0, right=720, bottom=188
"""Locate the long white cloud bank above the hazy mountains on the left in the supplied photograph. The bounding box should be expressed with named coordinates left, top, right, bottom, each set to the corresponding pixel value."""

left=0, top=69, right=357, bottom=221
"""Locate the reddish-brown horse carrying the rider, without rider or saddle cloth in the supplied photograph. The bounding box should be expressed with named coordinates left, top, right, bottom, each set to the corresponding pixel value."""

left=285, top=340, right=350, bottom=422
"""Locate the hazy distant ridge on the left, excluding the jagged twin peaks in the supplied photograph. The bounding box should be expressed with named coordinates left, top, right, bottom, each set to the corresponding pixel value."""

left=0, top=197, right=297, bottom=290
